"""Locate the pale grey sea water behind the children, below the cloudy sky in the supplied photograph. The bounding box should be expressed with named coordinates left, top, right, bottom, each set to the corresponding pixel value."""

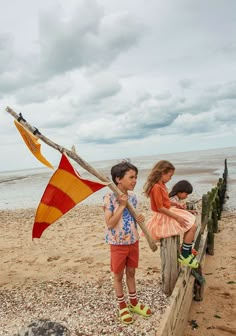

left=0, top=147, right=236, bottom=211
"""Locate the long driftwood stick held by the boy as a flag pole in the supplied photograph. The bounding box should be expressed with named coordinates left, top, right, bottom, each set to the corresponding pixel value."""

left=6, top=106, right=157, bottom=252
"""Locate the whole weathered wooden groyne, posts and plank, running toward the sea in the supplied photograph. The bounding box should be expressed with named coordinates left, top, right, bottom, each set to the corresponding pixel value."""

left=157, top=160, right=228, bottom=336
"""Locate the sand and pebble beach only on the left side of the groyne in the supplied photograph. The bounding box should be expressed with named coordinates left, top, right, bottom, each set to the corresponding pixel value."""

left=0, top=201, right=168, bottom=336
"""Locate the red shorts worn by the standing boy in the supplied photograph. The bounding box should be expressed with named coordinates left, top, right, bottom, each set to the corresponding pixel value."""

left=110, top=241, right=139, bottom=274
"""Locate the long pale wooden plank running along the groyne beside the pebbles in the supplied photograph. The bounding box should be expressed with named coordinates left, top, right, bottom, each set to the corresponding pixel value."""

left=158, top=228, right=208, bottom=336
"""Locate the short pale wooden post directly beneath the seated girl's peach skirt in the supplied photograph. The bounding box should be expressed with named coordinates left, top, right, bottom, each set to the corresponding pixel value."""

left=160, top=236, right=180, bottom=296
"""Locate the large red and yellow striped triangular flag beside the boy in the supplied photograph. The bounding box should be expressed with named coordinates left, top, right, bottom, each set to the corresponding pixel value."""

left=32, top=154, right=108, bottom=238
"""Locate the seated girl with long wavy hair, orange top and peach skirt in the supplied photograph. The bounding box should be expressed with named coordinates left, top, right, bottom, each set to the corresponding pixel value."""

left=144, top=160, right=199, bottom=268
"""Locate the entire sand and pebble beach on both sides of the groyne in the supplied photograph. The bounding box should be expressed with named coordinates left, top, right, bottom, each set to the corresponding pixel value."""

left=0, top=203, right=236, bottom=336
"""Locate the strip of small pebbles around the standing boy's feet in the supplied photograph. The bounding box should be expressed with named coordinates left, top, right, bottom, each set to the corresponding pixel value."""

left=0, top=279, right=168, bottom=336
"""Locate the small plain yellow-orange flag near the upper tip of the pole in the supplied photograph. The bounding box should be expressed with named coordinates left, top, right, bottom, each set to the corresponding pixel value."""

left=14, top=120, right=54, bottom=169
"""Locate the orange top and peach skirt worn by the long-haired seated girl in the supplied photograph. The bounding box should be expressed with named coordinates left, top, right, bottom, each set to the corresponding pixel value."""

left=146, top=182, right=196, bottom=240
